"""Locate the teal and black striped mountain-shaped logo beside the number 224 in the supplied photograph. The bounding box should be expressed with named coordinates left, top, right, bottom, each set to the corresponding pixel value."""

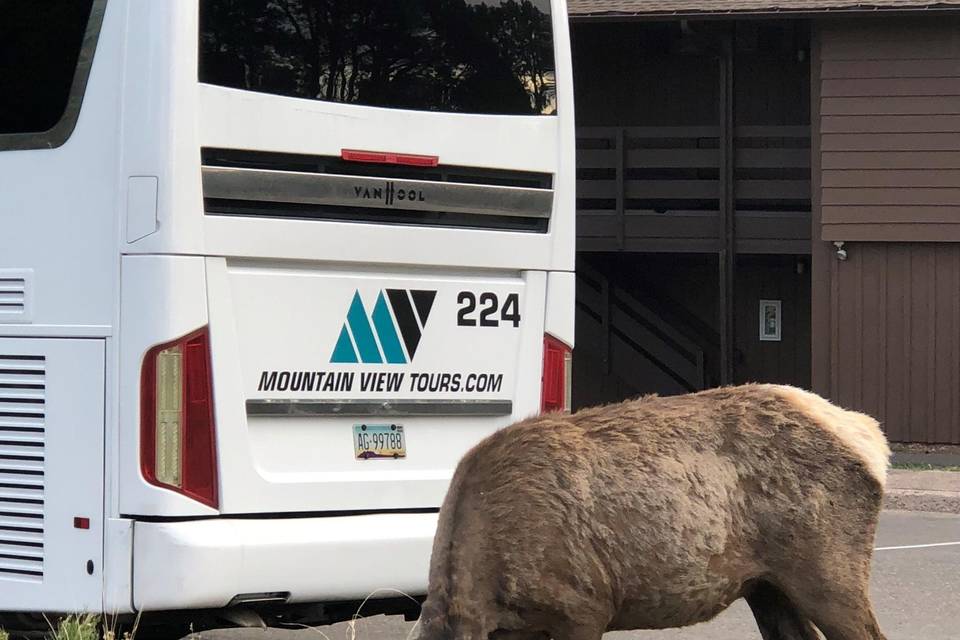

left=330, top=289, right=437, bottom=364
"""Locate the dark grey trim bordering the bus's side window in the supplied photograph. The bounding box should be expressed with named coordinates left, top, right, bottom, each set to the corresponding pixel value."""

left=0, top=0, right=107, bottom=151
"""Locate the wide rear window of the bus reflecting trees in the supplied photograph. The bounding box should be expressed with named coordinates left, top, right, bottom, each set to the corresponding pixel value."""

left=199, top=0, right=556, bottom=115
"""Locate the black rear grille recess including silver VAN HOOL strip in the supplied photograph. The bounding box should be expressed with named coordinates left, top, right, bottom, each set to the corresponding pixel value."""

left=202, top=149, right=553, bottom=233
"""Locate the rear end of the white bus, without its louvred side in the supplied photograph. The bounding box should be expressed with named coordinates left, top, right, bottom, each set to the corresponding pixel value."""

left=116, top=0, right=574, bottom=611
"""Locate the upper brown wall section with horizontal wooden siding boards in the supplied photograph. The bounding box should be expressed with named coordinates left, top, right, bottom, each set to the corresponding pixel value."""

left=815, top=16, right=960, bottom=241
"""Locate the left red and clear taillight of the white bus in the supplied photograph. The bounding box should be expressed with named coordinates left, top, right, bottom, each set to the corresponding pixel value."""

left=140, top=327, right=218, bottom=509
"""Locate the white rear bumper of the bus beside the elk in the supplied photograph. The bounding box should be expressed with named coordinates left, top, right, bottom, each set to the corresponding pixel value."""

left=133, top=513, right=437, bottom=611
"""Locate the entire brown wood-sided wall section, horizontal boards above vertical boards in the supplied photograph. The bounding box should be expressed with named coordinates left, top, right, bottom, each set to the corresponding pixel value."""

left=811, top=16, right=960, bottom=444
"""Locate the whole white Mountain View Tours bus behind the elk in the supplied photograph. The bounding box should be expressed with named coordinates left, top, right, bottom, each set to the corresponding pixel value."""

left=0, top=0, right=575, bottom=627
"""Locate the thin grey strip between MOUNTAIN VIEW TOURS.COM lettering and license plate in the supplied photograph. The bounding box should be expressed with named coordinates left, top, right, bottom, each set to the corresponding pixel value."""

left=247, top=399, right=513, bottom=417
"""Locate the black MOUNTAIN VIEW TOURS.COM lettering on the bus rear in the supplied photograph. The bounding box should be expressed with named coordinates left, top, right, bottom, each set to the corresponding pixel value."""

left=257, top=371, right=503, bottom=394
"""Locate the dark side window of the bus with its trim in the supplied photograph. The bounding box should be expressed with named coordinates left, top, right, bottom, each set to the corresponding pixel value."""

left=0, top=0, right=103, bottom=149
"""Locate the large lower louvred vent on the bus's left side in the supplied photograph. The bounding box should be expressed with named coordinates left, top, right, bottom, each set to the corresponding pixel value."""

left=0, top=354, right=46, bottom=582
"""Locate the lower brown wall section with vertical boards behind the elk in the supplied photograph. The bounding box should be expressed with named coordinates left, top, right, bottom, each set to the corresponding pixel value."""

left=830, top=243, right=960, bottom=444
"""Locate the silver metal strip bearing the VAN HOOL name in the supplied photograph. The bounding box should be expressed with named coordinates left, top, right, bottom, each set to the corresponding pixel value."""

left=203, top=165, right=553, bottom=218
